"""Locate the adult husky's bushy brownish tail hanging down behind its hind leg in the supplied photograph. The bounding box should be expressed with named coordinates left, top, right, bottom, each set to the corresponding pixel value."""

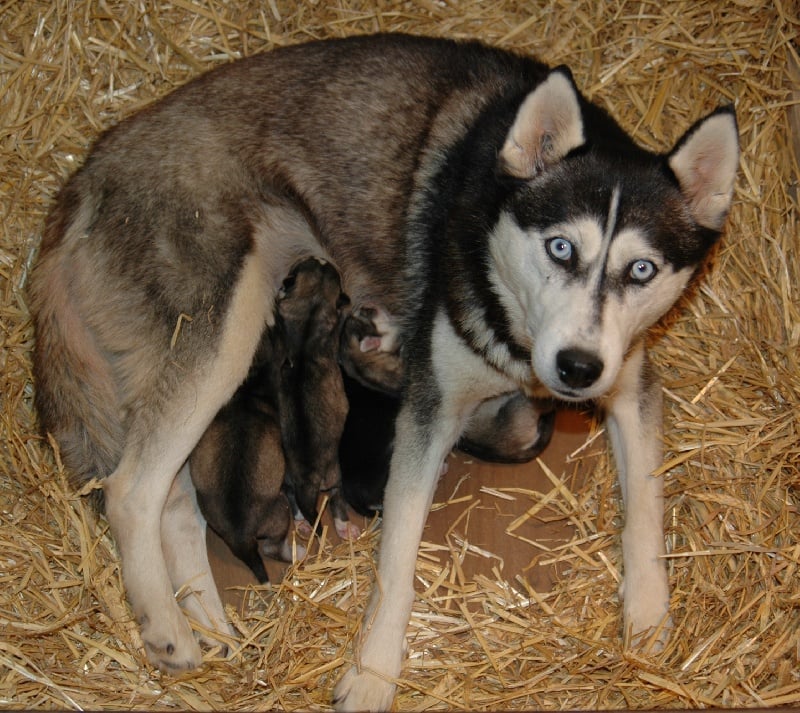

left=30, top=185, right=123, bottom=481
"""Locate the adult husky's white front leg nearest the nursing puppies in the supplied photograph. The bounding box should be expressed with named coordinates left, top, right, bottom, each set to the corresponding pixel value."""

left=334, top=403, right=461, bottom=711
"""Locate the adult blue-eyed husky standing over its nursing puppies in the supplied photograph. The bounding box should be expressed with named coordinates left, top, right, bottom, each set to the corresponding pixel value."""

left=31, top=35, right=738, bottom=709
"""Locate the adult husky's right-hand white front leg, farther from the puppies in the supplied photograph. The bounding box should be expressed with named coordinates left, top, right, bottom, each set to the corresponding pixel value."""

left=607, top=345, right=671, bottom=647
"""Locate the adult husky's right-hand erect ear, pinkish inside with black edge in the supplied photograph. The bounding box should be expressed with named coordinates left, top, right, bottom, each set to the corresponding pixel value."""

left=667, top=107, right=739, bottom=230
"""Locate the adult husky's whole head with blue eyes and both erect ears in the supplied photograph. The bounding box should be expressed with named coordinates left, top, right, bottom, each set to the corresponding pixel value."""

left=490, top=69, right=738, bottom=401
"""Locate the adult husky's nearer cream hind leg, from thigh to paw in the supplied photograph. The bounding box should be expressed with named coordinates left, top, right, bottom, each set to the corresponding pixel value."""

left=104, top=252, right=272, bottom=671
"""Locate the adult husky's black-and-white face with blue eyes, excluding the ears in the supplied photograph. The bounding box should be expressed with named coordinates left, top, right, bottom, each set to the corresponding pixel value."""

left=491, top=154, right=713, bottom=401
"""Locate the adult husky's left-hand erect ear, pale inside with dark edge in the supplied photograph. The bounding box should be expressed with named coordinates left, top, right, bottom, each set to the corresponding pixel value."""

left=500, top=67, right=584, bottom=179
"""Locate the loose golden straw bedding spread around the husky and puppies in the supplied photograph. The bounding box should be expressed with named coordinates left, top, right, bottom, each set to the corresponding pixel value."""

left=0, top=0, right=800, bottom=710
